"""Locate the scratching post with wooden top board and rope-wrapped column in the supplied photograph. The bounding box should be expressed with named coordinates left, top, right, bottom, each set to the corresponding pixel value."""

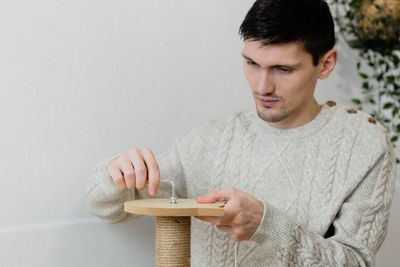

left=124, top=199, right=224, bottom=267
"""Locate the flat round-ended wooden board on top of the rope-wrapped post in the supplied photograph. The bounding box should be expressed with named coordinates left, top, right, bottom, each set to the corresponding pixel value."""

left=124, top=199, right=225, bottom=216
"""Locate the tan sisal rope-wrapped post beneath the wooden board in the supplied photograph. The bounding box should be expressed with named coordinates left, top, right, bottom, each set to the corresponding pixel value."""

left=156, top=216, right=191, bottom=267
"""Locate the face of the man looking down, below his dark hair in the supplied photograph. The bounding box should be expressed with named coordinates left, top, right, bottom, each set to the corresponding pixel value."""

left=242, top=41, right=320, bottom=128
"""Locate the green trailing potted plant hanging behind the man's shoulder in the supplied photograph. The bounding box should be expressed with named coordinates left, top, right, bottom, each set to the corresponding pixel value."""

left=330, top=0, right=400, bottom=163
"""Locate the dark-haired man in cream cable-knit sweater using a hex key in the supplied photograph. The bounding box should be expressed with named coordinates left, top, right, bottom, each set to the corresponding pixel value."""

left=87, top=0, right=395, bottom=266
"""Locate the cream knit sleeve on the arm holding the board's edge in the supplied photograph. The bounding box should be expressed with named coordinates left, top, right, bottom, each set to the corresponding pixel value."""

left=250, top=136, right=396, bottom=266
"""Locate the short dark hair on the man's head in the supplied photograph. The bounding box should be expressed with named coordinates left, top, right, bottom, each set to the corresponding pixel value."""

left=239, top=0, right=335, bottom=65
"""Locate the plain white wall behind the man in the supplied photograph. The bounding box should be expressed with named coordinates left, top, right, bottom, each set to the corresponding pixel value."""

left=0, top=0, right=400, bottom=267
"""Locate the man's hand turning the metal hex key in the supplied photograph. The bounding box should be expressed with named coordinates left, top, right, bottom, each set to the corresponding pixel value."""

left=106, top=148, right=160, bottom=195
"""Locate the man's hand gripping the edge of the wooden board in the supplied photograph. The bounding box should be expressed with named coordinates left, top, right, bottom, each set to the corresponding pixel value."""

left=196, top=187, right=264, bottom=242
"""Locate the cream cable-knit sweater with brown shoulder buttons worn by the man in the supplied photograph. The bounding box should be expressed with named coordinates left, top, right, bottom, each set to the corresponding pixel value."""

left=87, top=101, right=395, bottom=267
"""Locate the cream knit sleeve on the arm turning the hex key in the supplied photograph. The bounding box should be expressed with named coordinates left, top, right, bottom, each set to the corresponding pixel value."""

left=86, top=112, right=230, bottom=223
